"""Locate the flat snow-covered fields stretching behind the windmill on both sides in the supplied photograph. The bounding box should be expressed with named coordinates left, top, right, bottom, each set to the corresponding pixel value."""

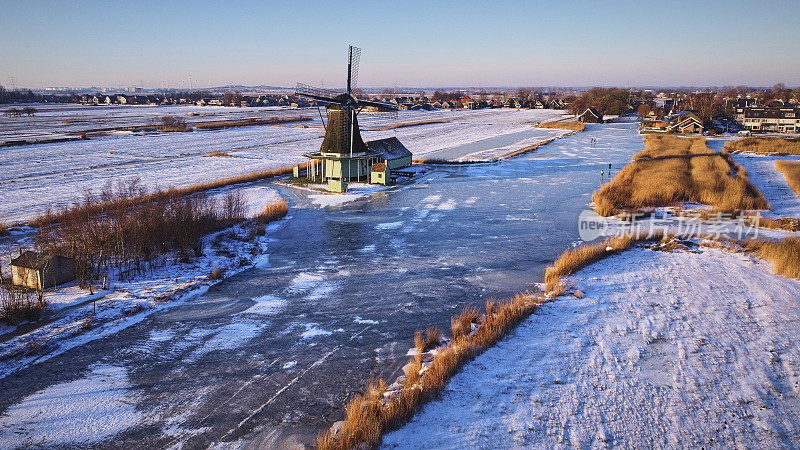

left=0, top=106, right=561, bottom=223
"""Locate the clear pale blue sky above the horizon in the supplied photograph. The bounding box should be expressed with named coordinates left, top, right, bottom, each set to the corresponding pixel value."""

left=0, top=0, right=800, bottom=88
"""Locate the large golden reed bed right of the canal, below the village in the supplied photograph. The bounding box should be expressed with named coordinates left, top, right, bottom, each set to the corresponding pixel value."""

left=592, top=135, right=769, bottom=216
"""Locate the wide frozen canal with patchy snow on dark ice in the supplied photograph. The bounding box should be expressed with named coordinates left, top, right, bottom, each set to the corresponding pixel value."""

left=0, top=119, right=643, bottom=448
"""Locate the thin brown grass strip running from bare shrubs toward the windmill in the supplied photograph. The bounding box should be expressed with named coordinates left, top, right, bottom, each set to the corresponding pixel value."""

left=28, top=166, right=292, bottom=227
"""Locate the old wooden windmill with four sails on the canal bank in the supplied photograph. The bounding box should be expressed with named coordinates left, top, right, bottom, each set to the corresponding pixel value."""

left=295, top=45, right=410, bottom=190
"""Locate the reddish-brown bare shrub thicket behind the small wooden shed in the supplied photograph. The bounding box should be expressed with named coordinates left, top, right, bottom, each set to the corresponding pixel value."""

left=36, top=179, right=245, bottom=286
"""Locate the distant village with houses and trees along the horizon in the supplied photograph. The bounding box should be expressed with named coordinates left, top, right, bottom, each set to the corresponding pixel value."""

left=0, top=84, right=800, bottom=134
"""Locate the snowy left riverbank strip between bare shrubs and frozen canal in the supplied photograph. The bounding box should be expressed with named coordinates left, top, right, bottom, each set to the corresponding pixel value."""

left=0, top=187, right=289, bottom=379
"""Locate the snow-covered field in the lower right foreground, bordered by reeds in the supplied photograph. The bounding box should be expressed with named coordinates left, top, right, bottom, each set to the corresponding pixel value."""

left=384, top=244, right=800, bottom=448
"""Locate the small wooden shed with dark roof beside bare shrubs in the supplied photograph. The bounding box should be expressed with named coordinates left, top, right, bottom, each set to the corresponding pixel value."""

left=11, top=251, right=75, bottom=289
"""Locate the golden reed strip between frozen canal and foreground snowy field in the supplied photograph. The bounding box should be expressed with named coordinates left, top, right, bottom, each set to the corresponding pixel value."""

left=317, top=232, right=657, bottom=450
